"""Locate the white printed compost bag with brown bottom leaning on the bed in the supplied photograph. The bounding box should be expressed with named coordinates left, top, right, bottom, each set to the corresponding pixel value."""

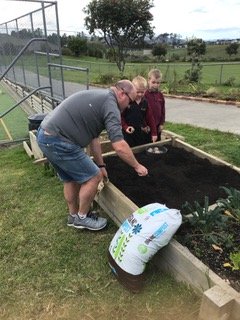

left=108, top=203, right=182, bottom=292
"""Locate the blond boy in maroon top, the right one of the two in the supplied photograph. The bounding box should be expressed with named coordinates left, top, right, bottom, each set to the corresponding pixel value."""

left=145, top=69, right=165, bottom=140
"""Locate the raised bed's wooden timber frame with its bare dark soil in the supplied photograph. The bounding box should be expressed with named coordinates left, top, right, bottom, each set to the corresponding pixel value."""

left=97, top=139, right=240, bottom=320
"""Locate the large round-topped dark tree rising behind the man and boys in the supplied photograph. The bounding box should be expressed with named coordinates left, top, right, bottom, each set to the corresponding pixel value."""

left=83, top=0, right=153, bottom=73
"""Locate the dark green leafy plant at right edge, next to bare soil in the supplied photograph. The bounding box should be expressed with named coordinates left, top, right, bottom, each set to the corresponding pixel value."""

left=217, top=186, right=240, bottom=222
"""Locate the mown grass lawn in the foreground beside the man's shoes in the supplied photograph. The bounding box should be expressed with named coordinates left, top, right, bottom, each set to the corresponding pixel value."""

left=0, top=146, right=200, bottom=320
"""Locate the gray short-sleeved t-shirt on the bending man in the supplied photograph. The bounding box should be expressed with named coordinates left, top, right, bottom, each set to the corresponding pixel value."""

left=41, top=89, right=123, bottom=147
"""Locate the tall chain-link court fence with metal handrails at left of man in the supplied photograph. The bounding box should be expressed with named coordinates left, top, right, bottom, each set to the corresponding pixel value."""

left=0, top=0, right=89, bottom=140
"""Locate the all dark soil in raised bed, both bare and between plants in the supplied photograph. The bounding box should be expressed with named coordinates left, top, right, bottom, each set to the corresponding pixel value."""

left=104, top=146, right=240, bottom=291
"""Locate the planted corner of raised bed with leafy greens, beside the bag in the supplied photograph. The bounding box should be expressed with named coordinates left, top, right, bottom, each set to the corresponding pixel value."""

left=176, top=187, right=240, bottom=291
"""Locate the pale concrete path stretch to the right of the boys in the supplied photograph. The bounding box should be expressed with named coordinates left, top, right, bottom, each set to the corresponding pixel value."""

left=165, top=98, right=240, bottom=135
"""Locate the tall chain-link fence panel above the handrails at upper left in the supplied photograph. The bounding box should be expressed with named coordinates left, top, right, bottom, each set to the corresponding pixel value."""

left=0, top=1, right=62, bottom=101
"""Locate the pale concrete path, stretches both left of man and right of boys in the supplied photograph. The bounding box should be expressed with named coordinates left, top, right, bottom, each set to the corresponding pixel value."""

left=4, top=72, right=240, bottom=135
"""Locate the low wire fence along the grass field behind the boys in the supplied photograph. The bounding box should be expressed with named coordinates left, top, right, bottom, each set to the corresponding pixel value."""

left=63, top=57, right=240, bottom=86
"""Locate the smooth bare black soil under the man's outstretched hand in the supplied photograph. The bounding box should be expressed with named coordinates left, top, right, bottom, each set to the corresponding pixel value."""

left=104, top=146, right=240, bottom=209
